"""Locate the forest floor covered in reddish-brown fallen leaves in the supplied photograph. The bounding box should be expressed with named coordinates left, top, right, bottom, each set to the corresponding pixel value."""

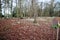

left=0, top=17, right=56, bottom=40
